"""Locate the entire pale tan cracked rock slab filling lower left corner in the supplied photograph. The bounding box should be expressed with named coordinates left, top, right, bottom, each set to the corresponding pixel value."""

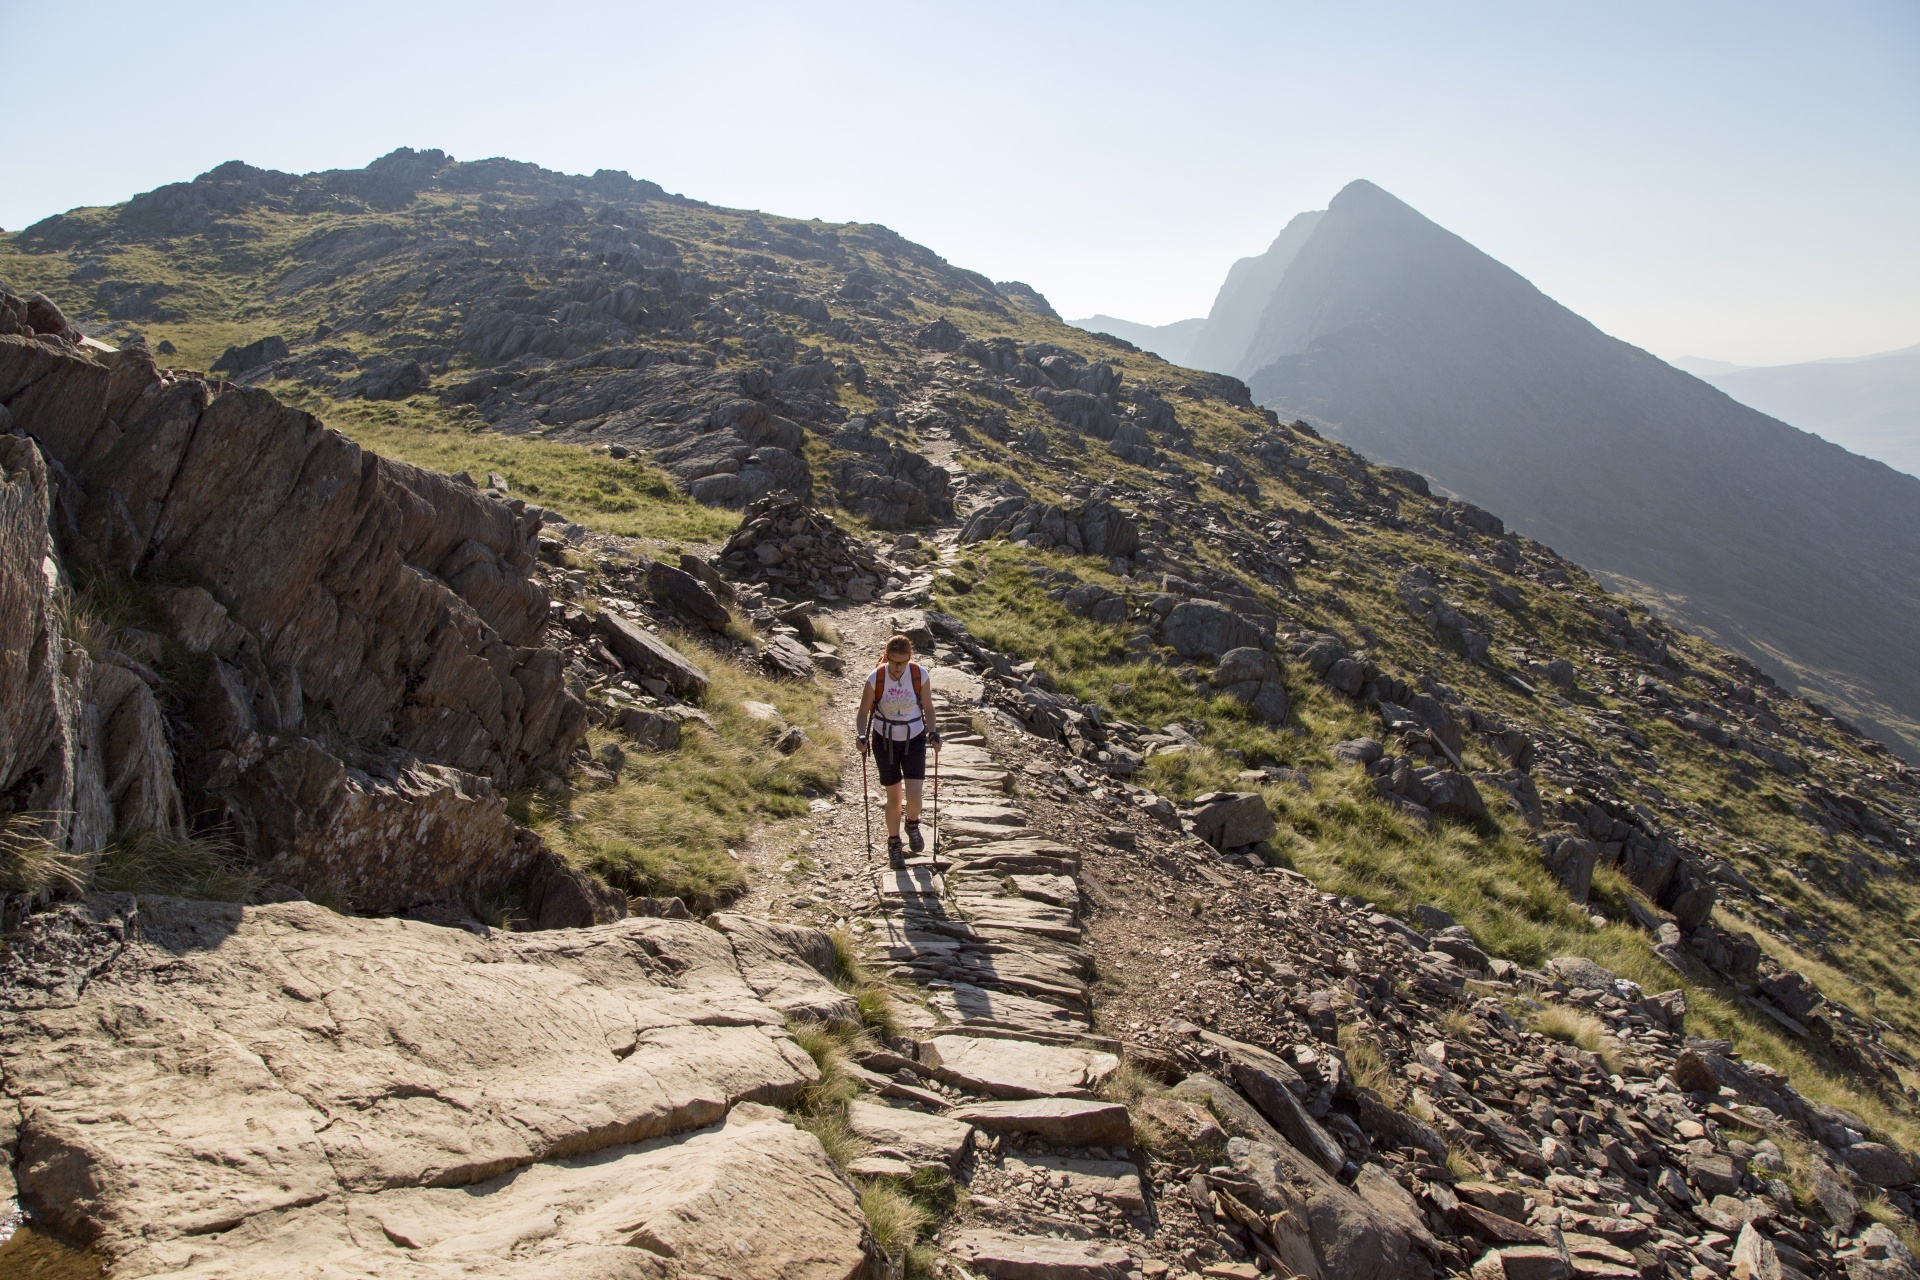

left=0, top=896, right=864, bottom=1280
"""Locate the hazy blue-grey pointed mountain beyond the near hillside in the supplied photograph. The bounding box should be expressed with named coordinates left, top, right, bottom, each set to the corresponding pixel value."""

left=1098, top=182, right=1920, bottom=758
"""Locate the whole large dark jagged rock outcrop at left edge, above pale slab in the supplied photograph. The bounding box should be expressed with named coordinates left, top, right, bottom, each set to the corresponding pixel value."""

left=0, top=293, right=586, bottom=912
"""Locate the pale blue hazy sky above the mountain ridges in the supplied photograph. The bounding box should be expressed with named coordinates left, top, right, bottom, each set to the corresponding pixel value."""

left=0, top=0, right=1920, bottom=363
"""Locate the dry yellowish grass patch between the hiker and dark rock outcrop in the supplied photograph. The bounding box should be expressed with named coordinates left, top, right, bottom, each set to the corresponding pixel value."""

left=541, top=635, right=841, bottom=912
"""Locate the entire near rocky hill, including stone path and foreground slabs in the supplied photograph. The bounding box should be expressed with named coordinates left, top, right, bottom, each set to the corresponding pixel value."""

left=0, top=150, right=1920, bottom=1280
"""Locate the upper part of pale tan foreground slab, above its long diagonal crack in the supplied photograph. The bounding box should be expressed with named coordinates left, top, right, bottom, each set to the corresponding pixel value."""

left=0, top=894, right=818, bottom=1274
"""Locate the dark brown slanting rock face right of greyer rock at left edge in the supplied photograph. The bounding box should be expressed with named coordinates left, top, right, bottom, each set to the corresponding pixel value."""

left=0, top=336, right=586, bottom=908
